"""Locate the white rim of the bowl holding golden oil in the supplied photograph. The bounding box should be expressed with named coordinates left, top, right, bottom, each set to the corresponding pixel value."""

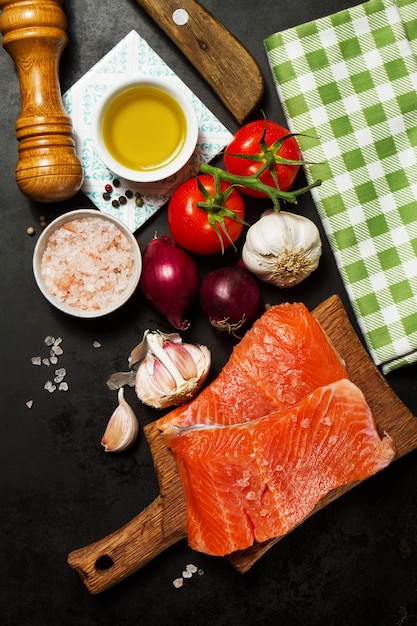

left=91, top=74, right=199, bottom=183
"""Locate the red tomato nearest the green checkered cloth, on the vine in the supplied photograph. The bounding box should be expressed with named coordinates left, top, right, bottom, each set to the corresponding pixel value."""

left=224, top=120, right=301, bottom=198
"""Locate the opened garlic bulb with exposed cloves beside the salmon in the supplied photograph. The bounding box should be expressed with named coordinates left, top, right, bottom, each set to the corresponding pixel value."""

left=130, top=331, right=211, bottom=409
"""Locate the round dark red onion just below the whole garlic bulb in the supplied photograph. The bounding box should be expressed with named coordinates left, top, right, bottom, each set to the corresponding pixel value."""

left=200, top=261, right=261, bottom=335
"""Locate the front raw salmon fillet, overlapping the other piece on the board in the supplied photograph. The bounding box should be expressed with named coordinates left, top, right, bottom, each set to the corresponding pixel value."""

left=167, top=379, right=395, bottom=556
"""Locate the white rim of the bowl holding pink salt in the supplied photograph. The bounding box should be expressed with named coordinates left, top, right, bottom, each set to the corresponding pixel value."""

left=32, top=209, right=142, bottom=319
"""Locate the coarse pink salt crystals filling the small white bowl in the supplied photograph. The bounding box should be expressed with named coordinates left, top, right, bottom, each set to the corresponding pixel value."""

left=41, top=217, right=134, bottom=310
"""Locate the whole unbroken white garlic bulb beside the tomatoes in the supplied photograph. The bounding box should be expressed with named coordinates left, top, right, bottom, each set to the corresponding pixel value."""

left=242, top=209, right=322, bottom=287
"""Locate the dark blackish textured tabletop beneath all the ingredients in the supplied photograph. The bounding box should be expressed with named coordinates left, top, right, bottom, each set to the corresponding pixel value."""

left=0, top=0, right=417, bottom=626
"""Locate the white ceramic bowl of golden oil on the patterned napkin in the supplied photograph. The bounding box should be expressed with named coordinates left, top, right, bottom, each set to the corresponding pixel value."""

left=92, top=76, right=199, bottom=183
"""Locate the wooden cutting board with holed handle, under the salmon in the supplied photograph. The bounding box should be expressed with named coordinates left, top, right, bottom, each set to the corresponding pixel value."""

left=68, top=296, right=417, bottom=593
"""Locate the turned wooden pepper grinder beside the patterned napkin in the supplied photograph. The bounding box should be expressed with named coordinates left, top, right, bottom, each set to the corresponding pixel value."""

left=0, top=0, right=83, bottom=202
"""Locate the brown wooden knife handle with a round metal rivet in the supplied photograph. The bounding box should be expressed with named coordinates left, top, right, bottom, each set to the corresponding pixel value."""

left=137, top=0, right=264, bottom=123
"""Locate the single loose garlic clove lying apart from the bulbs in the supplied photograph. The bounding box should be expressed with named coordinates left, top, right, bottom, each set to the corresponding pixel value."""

left=101, top=387, right=139, bottom=452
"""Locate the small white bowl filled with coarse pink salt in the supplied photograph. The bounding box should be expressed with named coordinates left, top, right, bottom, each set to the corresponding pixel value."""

left=33, top=209, right=142, bottom=318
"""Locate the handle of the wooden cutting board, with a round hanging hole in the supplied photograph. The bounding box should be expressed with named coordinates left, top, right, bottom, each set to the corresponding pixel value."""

left=68, top=494, right=186, bottom=594
